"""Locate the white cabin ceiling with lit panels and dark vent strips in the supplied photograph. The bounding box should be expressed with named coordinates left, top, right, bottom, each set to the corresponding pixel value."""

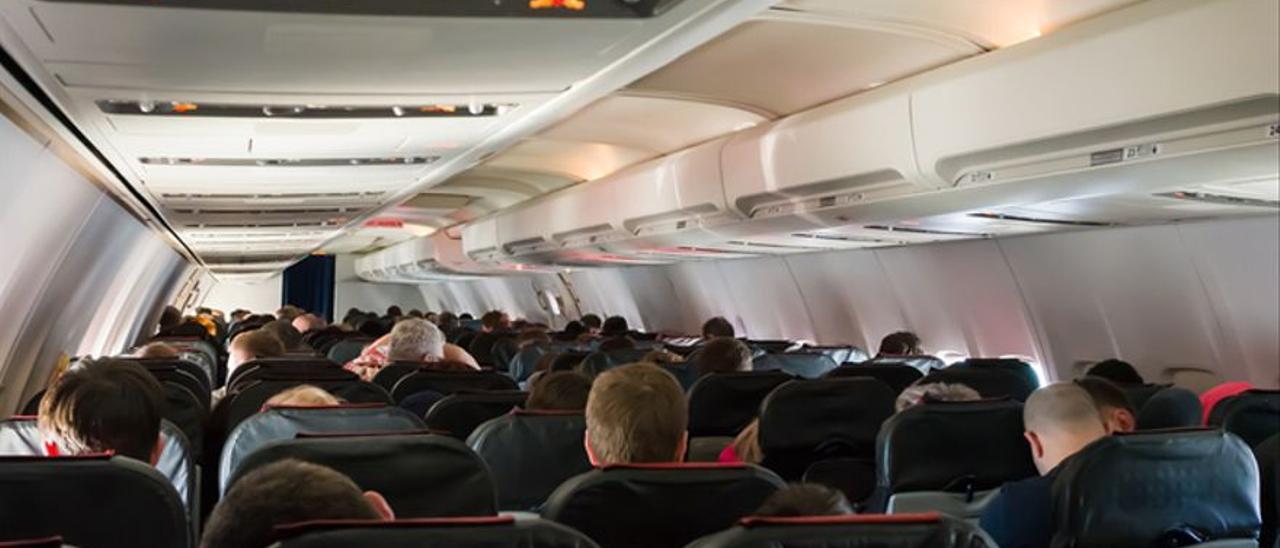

left=0, top=0, right=1162, bottom=274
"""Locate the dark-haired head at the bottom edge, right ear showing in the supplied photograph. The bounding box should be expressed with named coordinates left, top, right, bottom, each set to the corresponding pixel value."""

left=200, top=458, right=394, bottom=548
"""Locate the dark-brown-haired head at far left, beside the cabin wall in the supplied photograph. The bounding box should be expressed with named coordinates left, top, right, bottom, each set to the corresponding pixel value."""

left=38, top=360, right=165, bottom=463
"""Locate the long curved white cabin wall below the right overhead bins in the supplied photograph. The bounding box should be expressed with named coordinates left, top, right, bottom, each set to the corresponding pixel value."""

left=422, top=216, right=1280, bottom=388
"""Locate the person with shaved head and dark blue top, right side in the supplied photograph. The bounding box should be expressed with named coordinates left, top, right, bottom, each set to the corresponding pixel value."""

left=980, top=383, right=1107, bottom=548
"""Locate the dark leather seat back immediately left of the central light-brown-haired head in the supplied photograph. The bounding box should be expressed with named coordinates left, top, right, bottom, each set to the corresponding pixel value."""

left=467, top=410, right=591, bottom=510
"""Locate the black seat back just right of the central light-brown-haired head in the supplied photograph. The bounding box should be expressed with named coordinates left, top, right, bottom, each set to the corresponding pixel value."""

left=760, top=379, right=893, bottom=479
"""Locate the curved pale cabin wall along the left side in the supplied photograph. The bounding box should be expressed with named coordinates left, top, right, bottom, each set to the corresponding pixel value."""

left=0, top=111, right=187, bottom=414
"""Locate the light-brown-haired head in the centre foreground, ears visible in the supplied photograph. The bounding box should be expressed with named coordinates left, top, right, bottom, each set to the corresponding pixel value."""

left=586, top=364, right=689, bottom=466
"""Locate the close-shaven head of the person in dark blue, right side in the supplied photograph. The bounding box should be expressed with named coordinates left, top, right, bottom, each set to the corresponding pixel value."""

left=1023, top=383, right=1107, bottom=475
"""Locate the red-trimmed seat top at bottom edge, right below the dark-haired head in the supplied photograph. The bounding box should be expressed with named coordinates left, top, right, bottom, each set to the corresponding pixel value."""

left=276, top=516, right=596, bottom=548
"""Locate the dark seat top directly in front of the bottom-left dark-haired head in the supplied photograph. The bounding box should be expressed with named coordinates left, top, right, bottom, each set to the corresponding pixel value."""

left=228, top=433, right=497, bottom=517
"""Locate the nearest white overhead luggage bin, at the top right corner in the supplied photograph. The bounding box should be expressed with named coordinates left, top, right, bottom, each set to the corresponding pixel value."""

left=911, top=0, right=1280, bottom=199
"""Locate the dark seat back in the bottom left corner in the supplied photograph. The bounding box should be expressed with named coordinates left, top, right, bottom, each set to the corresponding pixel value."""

left=0, top=455, right=191, bottom=548
